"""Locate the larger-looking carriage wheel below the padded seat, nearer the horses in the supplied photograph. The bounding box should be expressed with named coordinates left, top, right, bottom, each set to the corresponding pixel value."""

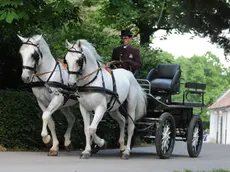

left=155, top=112, right=176, bottom=159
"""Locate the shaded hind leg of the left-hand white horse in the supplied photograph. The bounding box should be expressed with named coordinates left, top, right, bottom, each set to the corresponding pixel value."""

left=60, top=107, right=75, bottom=151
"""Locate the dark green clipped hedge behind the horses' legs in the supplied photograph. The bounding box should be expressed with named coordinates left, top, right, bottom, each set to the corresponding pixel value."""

left=0, top=90, right=119, bottom=150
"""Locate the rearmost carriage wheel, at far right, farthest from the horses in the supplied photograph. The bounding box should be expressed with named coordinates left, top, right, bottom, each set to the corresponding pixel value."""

left=187, top=116, right=203, bottom=157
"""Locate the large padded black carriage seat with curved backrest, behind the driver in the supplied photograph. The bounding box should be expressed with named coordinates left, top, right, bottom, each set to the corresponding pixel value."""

left=146, top=64, right=181, bottom=94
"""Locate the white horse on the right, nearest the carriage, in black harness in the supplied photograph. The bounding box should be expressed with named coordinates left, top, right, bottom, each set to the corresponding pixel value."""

left=65, top=40, right=147, bottom=159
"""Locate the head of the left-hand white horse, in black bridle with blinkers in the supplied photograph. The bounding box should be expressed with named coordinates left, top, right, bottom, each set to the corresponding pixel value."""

left=18, top=35, right=42, bottom=83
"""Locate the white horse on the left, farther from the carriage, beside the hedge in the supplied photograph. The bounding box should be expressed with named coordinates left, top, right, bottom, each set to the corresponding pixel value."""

left=18, top=35, right=77, bottom=156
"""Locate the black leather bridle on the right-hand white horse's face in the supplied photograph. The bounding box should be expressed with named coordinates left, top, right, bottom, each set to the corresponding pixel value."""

left=63, top=44, right=86, bottom=76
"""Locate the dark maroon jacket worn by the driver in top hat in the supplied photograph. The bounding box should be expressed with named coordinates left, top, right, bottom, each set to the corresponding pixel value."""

left=112, top=45, right=142, bottom=73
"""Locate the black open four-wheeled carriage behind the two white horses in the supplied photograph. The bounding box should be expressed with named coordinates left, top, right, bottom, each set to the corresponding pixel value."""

left=134, top=64, right=206, bottom=159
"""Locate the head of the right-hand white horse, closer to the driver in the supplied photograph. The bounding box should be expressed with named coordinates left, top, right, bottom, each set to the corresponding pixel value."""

left=64, top=40, right=86, bottom=86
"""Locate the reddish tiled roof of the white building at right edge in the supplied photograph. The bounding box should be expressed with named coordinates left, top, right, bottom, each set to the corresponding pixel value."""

left=208, top=89, right=230, bottom=109
